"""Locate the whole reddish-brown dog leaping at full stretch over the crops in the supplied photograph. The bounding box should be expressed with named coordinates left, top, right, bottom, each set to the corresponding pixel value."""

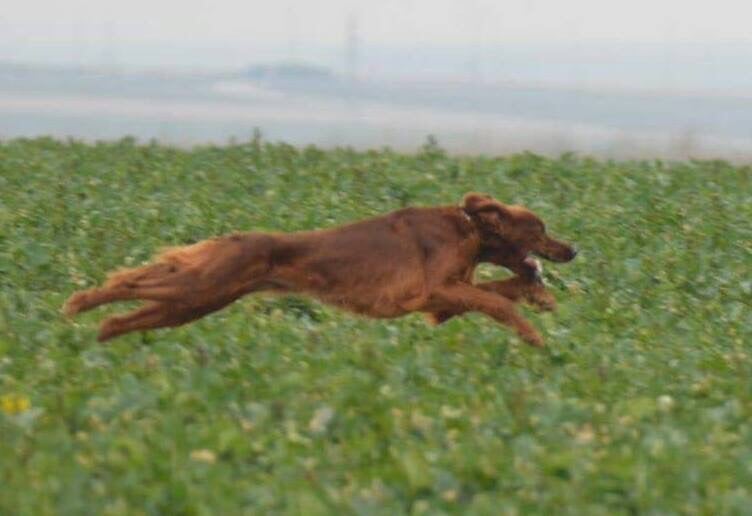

left=65, top=193, right=576, bottom=346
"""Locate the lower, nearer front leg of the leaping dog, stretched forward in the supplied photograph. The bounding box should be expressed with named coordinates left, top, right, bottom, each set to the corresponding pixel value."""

left=431, top=283, right=543, bottom=347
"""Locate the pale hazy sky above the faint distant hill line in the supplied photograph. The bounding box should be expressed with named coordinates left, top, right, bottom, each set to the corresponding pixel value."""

left=0, top=0, right=752, bottom=93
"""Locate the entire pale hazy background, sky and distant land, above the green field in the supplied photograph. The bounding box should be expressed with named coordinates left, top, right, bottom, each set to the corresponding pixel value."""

left=0, top=0, right=752, bottom=159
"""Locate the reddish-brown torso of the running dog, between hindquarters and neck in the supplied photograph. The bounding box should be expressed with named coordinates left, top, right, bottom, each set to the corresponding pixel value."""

left=269, top=208, right=472, bottom=317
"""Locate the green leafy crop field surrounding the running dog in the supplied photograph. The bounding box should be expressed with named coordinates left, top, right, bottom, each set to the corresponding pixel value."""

left=0, top=139, right=752, bottom=516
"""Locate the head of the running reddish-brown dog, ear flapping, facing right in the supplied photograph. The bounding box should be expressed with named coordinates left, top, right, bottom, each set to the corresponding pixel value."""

left=462, top=193, right=577, bottom=262
